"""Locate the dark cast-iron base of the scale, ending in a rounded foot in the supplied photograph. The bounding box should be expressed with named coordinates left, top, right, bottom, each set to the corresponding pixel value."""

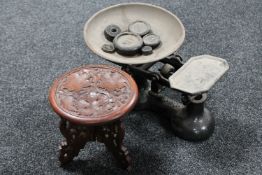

left=132, top=89, right=215, bottom=142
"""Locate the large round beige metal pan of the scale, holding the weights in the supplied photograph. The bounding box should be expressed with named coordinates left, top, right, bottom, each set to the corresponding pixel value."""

left=84, top=3, right=185, bottom=64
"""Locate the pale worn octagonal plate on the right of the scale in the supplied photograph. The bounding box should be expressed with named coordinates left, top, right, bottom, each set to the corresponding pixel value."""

left=169, top=55, right=229, bottom=94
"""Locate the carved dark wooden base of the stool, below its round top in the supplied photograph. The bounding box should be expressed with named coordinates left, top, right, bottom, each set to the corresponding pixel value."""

left=59, top=118, right=131, bottom=170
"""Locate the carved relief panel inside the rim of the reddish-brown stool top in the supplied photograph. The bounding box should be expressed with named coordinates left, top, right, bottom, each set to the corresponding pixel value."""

left=56, top=67, right=131, bottom=118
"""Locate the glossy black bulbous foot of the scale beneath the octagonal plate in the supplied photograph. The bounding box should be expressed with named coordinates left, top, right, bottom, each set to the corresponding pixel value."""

left=170, top=94, right=215, bottom=141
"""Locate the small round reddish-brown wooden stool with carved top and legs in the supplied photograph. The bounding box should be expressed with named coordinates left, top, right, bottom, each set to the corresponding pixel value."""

left=49, top=65, right=138, bottom=169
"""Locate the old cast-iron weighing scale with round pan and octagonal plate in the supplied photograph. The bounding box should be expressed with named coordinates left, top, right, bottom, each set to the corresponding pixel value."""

left=84, top=3, right=229, bottom=141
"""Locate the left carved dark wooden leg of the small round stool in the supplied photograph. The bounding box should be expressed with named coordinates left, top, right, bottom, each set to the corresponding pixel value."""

left=59, top=119, right=88, bottom=165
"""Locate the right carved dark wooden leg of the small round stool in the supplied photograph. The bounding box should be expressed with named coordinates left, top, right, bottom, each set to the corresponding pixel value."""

left=98, top=121, right=131, bottom=170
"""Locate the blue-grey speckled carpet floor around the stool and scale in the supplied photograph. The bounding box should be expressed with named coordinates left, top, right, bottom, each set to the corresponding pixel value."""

left=0, top=0, right=262, bottom=175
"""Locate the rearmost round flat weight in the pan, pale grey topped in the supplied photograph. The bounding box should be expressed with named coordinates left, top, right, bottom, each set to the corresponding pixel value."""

left=128, top=21, right=151, bottom=36
